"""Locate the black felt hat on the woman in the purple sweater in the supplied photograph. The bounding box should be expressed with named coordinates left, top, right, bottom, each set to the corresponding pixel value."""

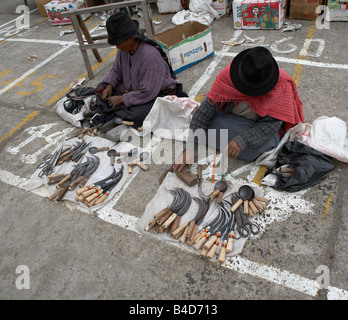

left=106, top=12, right=139, bottom=46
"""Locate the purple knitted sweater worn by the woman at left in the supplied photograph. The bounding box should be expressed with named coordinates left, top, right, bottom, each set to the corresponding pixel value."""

left=103, top=42, right=176, bottom=107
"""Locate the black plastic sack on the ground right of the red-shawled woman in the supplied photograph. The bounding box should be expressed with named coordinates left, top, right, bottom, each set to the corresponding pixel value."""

left=274, top=141, right=335, bottom=192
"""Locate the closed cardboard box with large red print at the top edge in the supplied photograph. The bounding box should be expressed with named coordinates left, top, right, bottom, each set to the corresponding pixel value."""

left=233, top=0, right=286, bottom=30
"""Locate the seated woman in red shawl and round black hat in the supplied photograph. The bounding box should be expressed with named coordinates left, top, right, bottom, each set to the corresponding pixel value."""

left=173, top=47, right=305, bottom=171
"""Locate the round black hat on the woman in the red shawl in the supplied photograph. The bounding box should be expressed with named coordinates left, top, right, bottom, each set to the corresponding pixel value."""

left=230, top=47, right=279, bottom=97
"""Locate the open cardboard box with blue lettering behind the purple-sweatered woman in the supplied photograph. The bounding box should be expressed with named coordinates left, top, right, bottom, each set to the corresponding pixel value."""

left=153, top=21, right=214, bottom=74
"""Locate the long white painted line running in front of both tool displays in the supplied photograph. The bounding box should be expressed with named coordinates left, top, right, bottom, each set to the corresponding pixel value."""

left=0, top=168, right=348, bottom=300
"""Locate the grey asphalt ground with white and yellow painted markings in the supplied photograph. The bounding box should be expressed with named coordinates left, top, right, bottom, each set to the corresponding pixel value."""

left=0, top=0, right=348, bottom=306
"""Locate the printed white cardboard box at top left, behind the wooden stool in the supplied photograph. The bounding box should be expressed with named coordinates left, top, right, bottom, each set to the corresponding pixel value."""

left=45, top=0, right=91, bottom=26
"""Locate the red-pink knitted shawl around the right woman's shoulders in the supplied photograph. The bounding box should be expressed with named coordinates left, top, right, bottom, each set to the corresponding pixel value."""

left=207, top=63, right=305, bottom=131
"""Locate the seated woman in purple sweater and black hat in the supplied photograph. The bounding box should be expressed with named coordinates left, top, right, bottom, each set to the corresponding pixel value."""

left=92, top=13, right=185, bottom=132
